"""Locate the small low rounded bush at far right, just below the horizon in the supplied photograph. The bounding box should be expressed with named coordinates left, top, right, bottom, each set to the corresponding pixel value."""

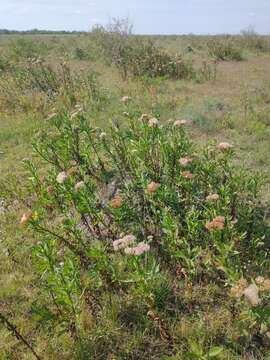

left=207, top=40, right=243, bottom=61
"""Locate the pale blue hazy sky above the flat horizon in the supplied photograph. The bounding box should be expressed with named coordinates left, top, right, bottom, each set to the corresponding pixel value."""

left=0, top=0, right=270, bottom=34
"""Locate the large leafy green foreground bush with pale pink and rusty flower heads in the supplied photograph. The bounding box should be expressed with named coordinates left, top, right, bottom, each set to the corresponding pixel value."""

left=21, top=108, right=269, bottom=359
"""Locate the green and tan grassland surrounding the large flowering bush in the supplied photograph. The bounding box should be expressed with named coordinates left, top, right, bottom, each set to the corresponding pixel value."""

left=0, top=34, right=270, bottom=360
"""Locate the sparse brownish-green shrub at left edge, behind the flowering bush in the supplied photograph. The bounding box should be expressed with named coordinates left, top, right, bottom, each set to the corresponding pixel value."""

left=0, top=58, right=106, bottom=108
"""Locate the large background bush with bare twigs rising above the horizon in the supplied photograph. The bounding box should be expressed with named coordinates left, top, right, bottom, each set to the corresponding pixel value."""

left=91, top=27, right=195, bottom=79
